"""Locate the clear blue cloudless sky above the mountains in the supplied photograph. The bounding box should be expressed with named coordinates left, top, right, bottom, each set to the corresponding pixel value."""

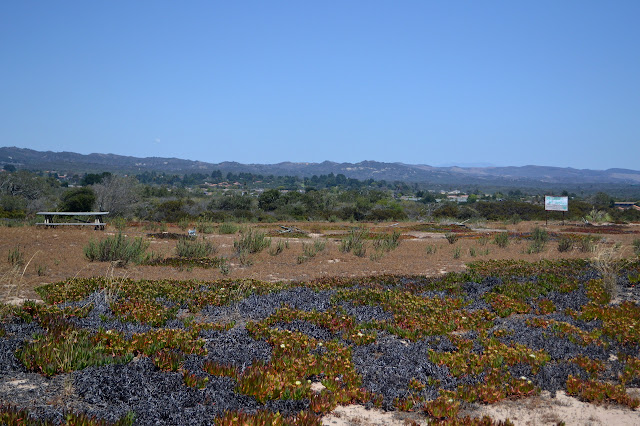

left=0, top=0, right=640, bottom=169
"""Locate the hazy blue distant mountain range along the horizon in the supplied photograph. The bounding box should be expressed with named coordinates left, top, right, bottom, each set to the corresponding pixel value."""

left=0, top=147, right=640, bottom=187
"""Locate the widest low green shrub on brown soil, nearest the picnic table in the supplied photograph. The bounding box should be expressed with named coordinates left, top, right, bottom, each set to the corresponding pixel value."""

left=84, top=232, right=149, bottom=266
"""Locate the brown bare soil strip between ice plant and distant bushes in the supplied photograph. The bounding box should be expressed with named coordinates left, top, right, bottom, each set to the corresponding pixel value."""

left=0, top=222, right=640, bottom=301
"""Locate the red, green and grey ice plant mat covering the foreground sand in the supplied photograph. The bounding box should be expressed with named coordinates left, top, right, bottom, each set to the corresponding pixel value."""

left=0, top=260, right=640, bottom=425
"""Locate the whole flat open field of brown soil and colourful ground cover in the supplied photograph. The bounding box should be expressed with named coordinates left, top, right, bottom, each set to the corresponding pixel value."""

left=0, top=222, right=640, bottom=424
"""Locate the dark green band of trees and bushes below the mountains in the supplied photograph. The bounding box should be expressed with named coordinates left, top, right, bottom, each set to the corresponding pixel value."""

left=0, top=168, right=640, bottom=222
